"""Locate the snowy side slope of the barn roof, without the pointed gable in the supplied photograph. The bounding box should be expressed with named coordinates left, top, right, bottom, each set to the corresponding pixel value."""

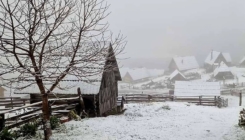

left=12, top=68, right=103, bottom=94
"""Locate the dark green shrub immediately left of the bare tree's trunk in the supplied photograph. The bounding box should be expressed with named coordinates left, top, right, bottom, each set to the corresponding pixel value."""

left=20, top=122, right=37, bottom=136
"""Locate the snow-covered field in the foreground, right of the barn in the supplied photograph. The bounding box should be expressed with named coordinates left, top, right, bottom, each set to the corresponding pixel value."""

left=52, top=96, right=245, bottom=140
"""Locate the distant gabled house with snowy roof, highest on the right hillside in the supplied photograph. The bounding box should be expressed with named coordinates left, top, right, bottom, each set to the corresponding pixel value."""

left=204, top=51, right=231, bottom=72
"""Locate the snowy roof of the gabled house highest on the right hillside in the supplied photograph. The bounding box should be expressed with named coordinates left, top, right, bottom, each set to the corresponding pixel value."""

left=205, top=51, right=231, bottom=65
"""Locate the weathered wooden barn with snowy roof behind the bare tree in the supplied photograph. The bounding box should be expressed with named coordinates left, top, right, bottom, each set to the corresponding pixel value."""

left=14, top=44, right=122, bottom=116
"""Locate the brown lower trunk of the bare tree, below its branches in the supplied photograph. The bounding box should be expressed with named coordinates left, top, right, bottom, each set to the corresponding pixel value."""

left=42, top=93, right=52, bottom=140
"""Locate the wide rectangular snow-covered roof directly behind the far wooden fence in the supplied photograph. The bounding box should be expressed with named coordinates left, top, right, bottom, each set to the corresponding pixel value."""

left=174, top=81, right=220, bottom=96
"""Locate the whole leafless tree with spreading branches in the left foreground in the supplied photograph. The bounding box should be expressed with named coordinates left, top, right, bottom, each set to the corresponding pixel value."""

left=0, top=0, right=125, bottom=139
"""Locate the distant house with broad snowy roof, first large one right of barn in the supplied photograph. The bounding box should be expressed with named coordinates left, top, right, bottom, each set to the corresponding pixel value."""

left=169, top=56, right=199, bottom=72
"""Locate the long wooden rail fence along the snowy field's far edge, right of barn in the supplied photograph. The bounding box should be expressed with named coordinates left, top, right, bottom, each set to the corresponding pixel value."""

left=125, top=94, right=228, bottom=107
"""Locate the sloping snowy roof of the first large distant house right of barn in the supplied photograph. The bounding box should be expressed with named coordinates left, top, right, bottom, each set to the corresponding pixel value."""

left=173, top=56, right=199, bottom=71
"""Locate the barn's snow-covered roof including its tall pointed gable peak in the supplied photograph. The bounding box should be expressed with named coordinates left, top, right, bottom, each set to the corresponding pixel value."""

left=14, top=44, right=121, bottom=94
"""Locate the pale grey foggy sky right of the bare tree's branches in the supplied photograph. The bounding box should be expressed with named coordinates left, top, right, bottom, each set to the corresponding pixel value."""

left=107, top=0, right=245, bottom=68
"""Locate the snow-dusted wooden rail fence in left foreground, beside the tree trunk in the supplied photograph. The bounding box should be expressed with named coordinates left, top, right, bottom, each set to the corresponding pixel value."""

left=0, top=95, right=81, bottom=131
